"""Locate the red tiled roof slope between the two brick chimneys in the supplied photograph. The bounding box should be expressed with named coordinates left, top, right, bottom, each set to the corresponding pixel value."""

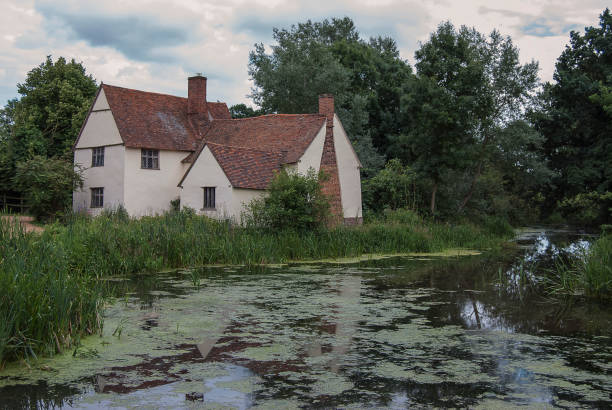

left=204, top=114, right=325, bottom=163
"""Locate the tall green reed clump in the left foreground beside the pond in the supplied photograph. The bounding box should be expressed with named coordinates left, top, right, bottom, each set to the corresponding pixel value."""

left=0, top=219, right=101, bottom=368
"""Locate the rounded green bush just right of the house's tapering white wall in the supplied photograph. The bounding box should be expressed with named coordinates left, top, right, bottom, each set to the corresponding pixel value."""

left=362, top=159, right=418, bottom=212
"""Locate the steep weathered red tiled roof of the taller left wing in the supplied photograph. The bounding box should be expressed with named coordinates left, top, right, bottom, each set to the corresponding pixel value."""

left=102, top=84, right=231, bottom=151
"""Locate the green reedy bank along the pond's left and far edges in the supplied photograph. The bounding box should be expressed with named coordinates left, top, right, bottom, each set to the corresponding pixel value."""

left=0, top=212, right=512, bottom=363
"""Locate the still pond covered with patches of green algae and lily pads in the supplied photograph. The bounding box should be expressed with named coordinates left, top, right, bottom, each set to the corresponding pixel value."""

left=0, top=230, right=612, bottom=409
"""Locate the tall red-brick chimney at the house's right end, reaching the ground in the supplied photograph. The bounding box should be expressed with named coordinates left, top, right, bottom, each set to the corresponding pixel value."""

left=319, top=94, right=344, bottom=226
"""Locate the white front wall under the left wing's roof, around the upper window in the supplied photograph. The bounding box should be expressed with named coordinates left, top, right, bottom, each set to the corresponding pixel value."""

left=124, top=148, right=189, bottom=217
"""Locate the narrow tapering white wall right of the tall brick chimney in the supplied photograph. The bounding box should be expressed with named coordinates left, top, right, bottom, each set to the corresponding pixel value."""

left=334, top=115, right=362, bottom=218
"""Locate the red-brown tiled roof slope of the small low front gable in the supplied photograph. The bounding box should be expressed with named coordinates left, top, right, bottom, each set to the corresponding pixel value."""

left=206, top=143, right=283, bottom=189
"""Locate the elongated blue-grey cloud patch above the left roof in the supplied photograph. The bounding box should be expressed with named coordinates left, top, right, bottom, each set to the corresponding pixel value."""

left=37, top=5, right=189, bottom=62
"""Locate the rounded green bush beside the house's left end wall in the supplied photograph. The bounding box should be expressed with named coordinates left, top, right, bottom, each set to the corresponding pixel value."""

left=14, top=155, right=83, bottom=219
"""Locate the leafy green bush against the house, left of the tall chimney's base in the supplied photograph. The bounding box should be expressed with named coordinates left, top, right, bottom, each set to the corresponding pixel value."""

left=243, top=168, right=329, bottom=231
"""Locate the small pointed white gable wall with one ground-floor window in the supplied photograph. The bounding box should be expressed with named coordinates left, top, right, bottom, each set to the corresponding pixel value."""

left=180, top=147, right=233, bottom=220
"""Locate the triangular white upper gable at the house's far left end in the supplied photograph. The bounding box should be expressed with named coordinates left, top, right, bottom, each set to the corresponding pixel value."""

left=75, top=90, right=123, bottom=149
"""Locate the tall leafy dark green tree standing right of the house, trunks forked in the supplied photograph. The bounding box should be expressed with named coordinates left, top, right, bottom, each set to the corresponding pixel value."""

left=393, top=22, right=539, bottom=213
